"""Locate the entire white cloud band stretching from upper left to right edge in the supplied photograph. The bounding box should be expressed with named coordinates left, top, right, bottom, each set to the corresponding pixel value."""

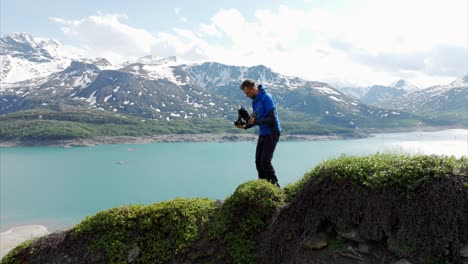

left=49, top=0, right=468, bottom=87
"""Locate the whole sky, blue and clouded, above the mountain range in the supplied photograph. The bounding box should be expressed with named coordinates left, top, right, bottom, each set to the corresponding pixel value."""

left=0, top=0, right=468, bottom=87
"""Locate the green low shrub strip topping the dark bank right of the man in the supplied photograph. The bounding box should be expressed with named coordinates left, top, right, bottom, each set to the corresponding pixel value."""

left=284, top=154, right=468, bottom=201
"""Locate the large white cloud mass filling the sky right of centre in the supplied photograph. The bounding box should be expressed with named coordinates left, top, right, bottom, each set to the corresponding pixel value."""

left=182, top=0, right=468, bottom=87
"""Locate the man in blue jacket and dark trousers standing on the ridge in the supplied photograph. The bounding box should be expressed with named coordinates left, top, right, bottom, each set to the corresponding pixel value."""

left=237, top=80, right=281, bottom=187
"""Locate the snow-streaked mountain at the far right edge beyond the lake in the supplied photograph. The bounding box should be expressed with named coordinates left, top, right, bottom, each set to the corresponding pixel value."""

left=385, top=75, right=468, bottom=113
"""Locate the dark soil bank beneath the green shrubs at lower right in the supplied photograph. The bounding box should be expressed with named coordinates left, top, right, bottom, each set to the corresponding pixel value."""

left=258, top=174, right=468, bottom=264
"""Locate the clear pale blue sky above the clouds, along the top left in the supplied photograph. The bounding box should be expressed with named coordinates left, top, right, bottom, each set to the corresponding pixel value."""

left=1, top=0, right=349, bottom=39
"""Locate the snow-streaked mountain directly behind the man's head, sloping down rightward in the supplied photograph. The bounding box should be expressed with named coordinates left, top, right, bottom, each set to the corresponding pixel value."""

left=177, top=62, right=401, bottom=127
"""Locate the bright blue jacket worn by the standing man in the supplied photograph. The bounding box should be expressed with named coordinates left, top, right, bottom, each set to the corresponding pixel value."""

left=252, top=85, right=281, bottom=136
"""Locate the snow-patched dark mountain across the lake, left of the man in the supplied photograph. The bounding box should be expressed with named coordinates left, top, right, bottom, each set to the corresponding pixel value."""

left=0, top=58, right=238, bottom=120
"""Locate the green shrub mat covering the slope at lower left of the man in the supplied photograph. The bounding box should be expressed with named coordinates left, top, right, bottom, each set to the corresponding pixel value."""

left=73, top=198, right=215, bottom=263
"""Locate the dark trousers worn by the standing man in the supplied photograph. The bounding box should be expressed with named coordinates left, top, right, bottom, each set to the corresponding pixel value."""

left=255, top=133, right=280, bottom=184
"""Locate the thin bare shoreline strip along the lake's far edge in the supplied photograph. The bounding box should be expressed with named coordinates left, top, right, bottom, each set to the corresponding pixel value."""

left=0, top=126, right=467, bottom=148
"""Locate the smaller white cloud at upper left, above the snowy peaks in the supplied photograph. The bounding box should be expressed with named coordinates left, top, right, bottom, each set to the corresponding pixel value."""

left=50, top=13, right=156, bottom=62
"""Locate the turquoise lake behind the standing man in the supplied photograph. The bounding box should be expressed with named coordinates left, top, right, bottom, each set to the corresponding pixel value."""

left=0, top=129, right=468, bottom=232
